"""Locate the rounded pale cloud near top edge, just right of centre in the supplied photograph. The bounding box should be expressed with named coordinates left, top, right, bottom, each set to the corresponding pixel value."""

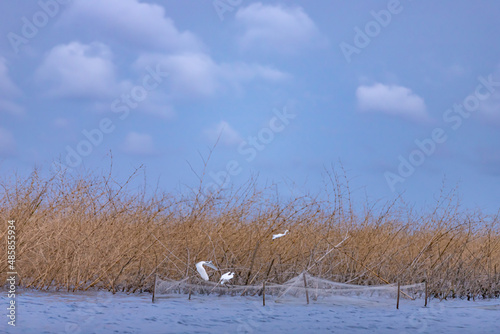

left=235, top=2, right=325, bottom=53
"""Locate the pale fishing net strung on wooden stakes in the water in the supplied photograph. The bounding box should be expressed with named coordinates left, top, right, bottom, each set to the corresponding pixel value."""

left=154, top=272, right=425, bottom=306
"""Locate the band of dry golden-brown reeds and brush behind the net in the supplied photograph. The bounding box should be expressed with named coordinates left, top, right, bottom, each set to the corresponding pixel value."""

left=0, top=166, right=500, bottom=298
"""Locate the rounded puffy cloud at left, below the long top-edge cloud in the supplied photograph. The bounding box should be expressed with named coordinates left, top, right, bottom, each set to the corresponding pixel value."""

left=35, top=42, right=122, bottom=99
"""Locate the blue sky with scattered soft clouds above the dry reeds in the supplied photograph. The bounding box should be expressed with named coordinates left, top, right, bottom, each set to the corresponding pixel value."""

left=0, top=0, right=500, bottom=213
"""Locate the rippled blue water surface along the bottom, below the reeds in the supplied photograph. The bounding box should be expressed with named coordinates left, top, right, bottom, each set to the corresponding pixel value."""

left=0, top=291, right=500, bottom=334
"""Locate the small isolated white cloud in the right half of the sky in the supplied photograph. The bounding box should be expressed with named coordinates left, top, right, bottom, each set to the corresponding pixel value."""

left=356, top=83, right=430, bottom=121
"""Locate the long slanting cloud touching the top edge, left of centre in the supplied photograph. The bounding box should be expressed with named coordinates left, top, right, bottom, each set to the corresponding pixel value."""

left=59, top=0, right=203, bottom=51
